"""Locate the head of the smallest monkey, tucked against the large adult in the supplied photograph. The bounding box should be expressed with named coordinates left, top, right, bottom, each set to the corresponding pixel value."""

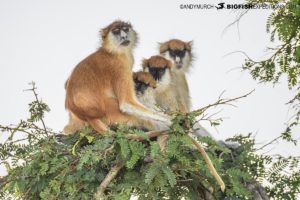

left=133, top=71, right=156, bottom=97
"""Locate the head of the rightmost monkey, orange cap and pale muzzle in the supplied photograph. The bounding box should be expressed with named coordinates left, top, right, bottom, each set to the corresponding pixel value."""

left=159, top=39, right=193, bottom=73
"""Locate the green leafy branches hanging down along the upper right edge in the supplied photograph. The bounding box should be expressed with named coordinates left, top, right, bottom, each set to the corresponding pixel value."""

left=243, top=0, right=300, bottom=145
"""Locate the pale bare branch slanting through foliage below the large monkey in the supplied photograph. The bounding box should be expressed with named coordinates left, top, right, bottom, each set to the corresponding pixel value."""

left=95, top=163, right=124, bottom=199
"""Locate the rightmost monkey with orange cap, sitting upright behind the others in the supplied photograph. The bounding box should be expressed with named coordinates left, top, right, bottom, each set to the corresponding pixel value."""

left=159, top=39, right=193, bottom=113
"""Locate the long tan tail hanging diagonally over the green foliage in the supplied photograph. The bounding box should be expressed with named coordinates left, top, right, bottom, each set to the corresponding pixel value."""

left=189, top=136, right=225, bottom=192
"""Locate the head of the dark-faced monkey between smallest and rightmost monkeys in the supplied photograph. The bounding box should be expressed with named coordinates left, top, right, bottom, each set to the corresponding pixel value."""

left=142, top=56, right=172, bottom=90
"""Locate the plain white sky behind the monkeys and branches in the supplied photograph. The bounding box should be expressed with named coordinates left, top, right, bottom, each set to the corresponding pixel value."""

left=0, top=0, right=300, bottom=180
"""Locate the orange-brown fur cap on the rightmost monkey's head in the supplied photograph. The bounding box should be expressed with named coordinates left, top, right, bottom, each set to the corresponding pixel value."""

left=159, top=39, right=192, bottom=53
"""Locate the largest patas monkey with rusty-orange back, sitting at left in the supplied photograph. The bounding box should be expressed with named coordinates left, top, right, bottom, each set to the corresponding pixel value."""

left=65, top=21, right=171, bottom=133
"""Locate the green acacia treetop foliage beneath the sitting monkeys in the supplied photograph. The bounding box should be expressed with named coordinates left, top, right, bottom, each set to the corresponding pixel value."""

left=0, top=88, right=300, bottom=200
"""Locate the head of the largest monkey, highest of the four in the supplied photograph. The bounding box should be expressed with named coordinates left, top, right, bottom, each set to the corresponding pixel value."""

left=101, top=20, right=137, bottom=53
